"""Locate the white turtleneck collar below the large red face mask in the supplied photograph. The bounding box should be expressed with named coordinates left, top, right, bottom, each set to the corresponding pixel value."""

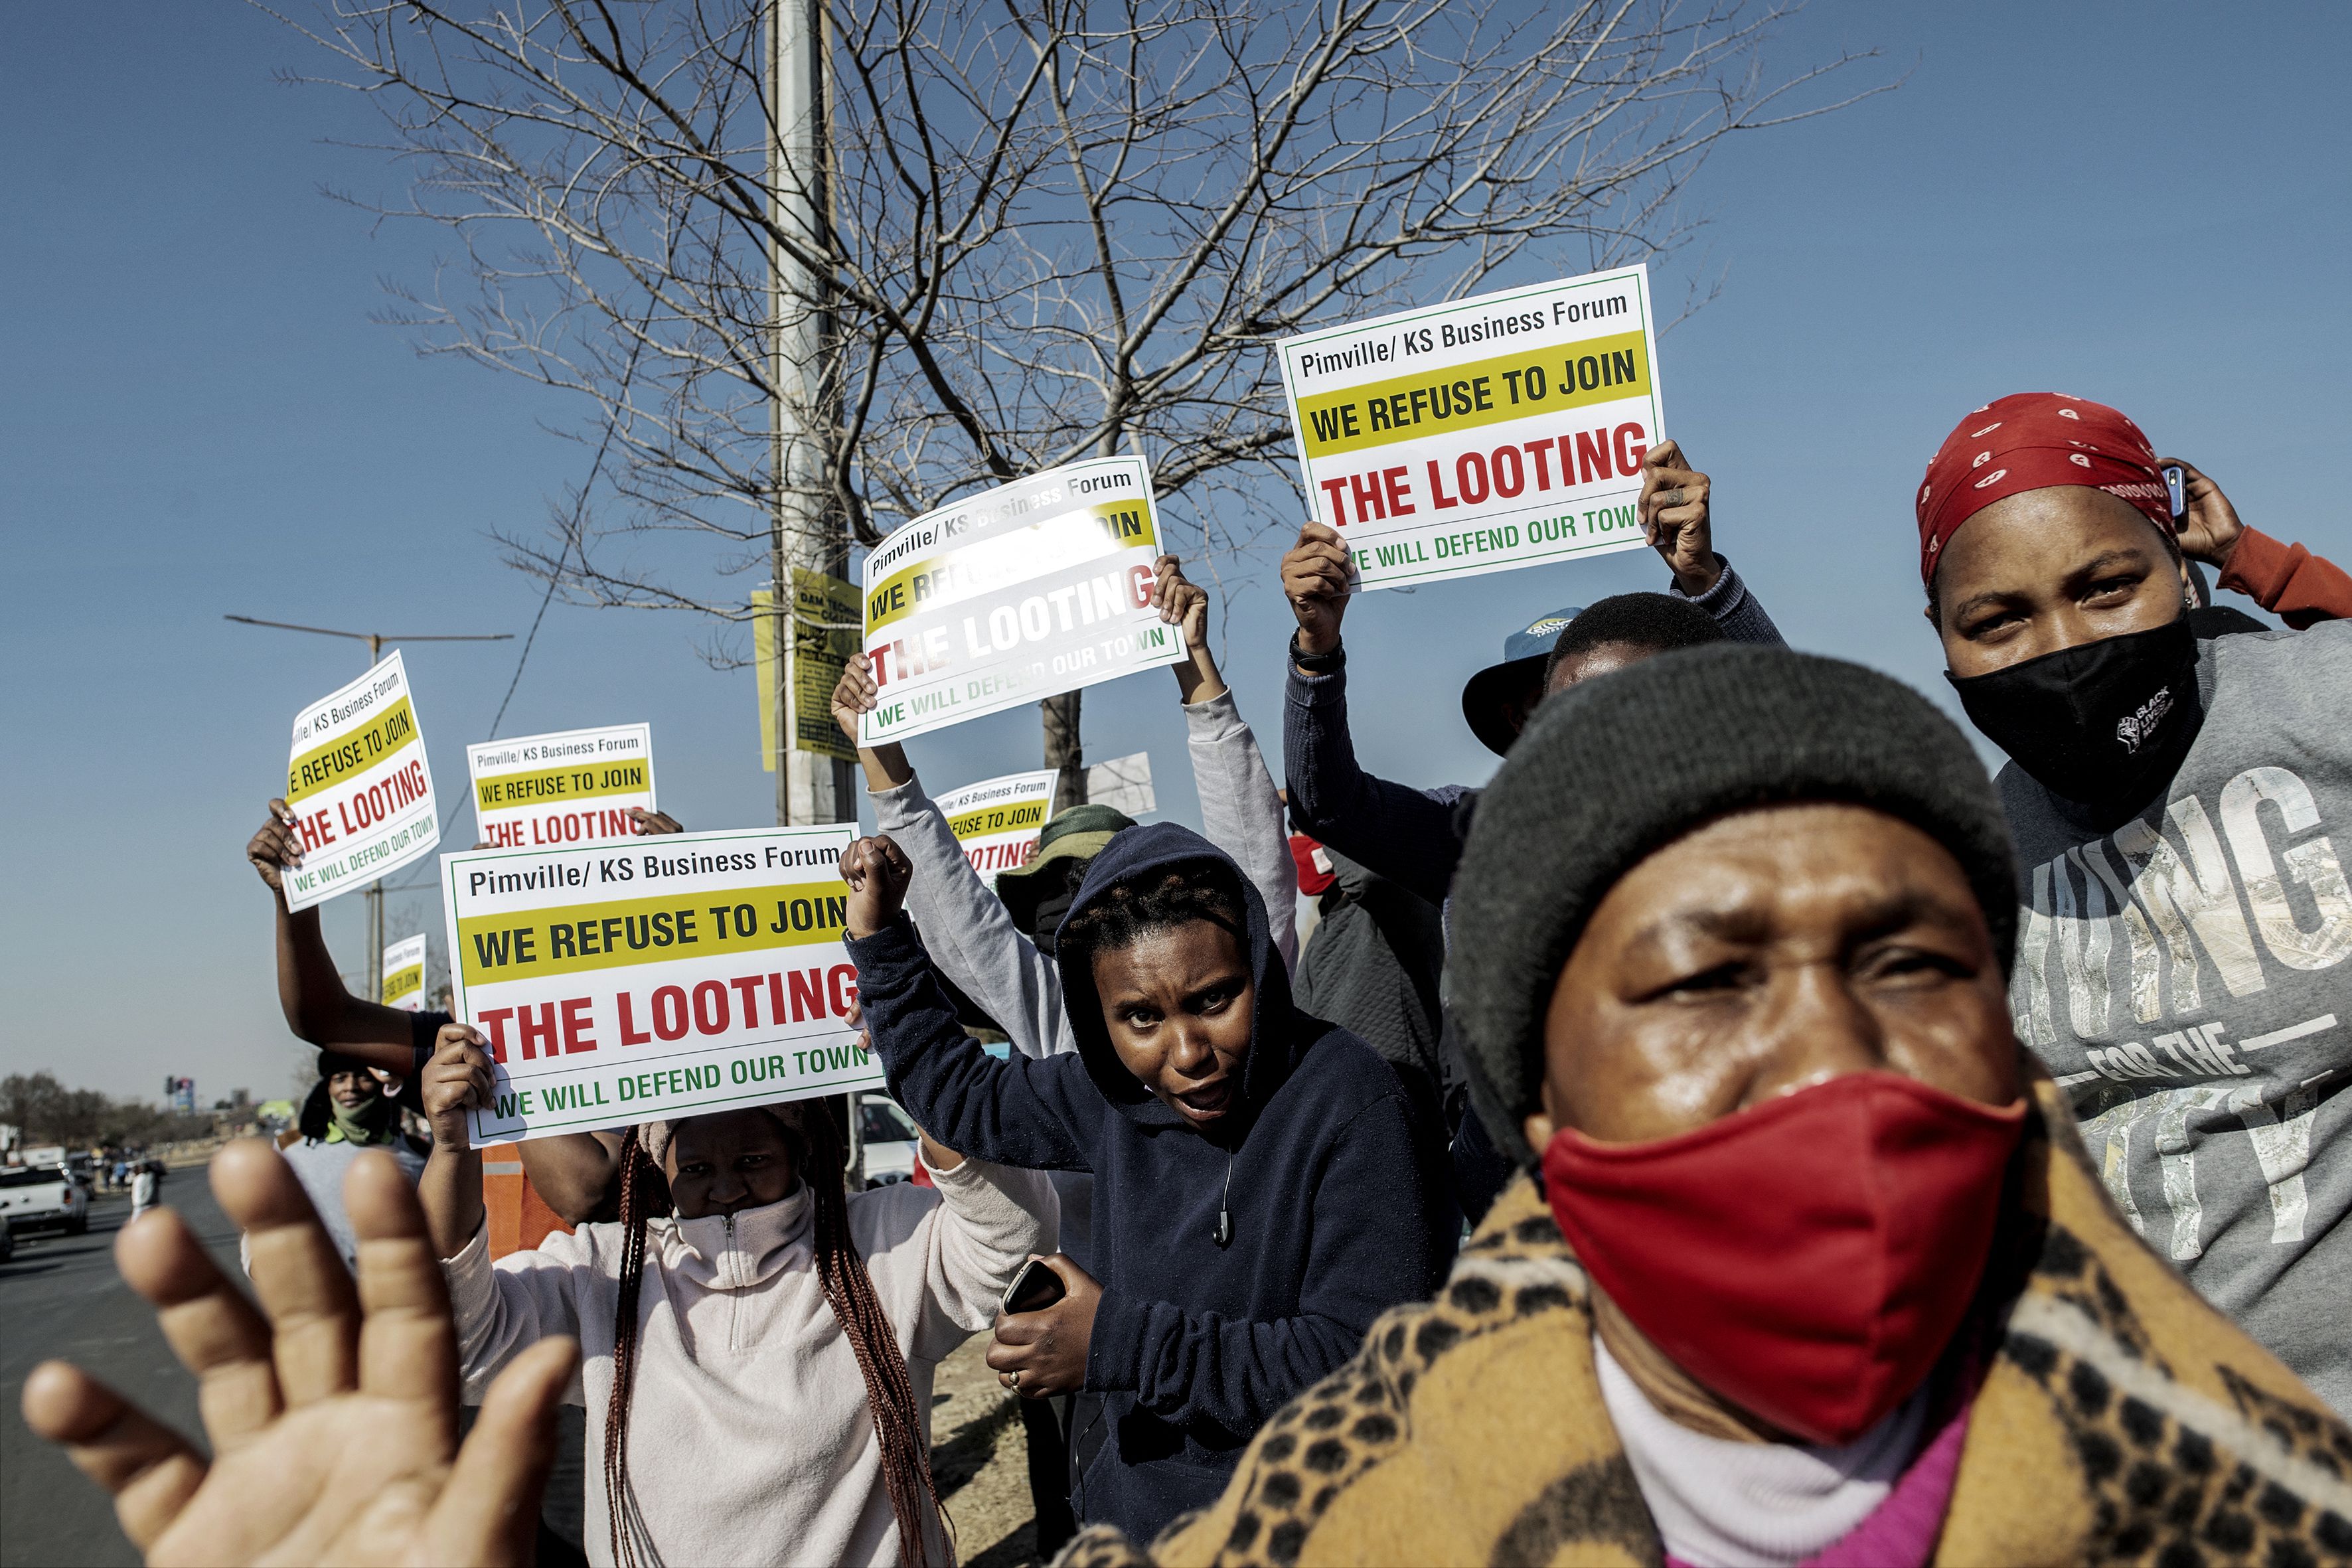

left=1593, top=1338, right=1926, bottom=1568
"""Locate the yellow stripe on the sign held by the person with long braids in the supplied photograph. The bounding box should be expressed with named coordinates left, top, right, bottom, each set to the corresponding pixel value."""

left=456, top=879, right=849, bottom=985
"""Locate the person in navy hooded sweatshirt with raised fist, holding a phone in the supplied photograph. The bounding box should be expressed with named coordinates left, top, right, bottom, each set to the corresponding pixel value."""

left=842, top=823, right=1458, bottom=1535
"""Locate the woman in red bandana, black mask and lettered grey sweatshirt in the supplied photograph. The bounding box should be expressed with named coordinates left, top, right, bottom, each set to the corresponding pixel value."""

left=1917, top=392, right=2352, bottom=1413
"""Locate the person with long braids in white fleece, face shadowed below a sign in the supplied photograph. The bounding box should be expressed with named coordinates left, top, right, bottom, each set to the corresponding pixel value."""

left=419, top=1025, right=1054, bottom=1568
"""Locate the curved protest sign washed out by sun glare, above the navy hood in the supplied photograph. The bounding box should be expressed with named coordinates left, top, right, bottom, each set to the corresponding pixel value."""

left=861, top=456, right=1186, bottom=745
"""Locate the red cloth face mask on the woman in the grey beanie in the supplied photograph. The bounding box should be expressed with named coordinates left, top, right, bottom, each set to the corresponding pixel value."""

left=1543, top=1072, right=2025, bottom=1443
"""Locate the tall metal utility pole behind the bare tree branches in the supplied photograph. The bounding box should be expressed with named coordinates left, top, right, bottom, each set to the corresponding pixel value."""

left=767, top=0, right=866, bottom=1175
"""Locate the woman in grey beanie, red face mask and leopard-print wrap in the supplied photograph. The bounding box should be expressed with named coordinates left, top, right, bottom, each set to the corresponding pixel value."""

left=1058, top=649, right=2352, bottom=1568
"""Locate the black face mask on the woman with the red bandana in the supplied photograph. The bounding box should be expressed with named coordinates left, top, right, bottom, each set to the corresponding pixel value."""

left=1945, top=616, right=2204, bottom=813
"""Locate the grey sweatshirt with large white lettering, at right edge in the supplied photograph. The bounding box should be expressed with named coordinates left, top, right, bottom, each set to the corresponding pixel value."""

left=1999, top=621, right=2352, bottom=1415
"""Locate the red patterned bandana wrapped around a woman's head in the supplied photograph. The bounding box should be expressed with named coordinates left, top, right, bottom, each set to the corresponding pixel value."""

left=1919, top=392, right=2173, bottom=583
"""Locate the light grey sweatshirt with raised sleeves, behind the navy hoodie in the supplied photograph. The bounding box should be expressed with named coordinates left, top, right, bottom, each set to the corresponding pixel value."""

left=870, top=691, right=1298, bottom=1263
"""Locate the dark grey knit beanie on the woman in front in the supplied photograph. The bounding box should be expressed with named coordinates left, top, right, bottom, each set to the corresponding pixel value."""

left=1447, top=644, right=2018, bottom=1168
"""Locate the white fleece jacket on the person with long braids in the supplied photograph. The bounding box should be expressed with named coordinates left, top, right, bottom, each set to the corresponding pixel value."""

left=442, top=1159, right=1056, bottom=1568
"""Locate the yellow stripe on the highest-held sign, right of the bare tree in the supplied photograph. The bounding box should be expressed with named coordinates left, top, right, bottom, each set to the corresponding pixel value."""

left=1298, top=331, right=1649, bottom=459
